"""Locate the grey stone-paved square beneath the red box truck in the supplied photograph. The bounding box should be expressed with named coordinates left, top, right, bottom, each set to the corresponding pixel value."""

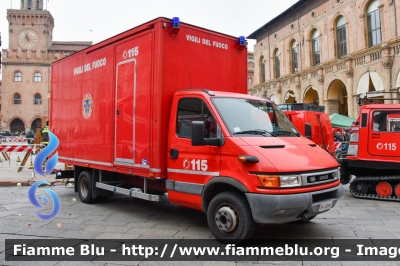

left=0, top=185, right=400, bottom=266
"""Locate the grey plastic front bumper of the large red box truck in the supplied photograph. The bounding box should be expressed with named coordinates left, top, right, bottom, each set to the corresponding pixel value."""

left=245, top=184, right=343, bottom=224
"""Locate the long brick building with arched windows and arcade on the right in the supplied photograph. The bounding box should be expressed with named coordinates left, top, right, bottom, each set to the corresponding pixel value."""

left=248, top=0, right=400, bottom=117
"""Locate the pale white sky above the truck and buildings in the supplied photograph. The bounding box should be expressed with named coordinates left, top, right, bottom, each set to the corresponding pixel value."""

left=0, top=0, right=297, bottom=64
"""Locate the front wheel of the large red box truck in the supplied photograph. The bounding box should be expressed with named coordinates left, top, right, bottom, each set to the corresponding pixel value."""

left=207, top=191, right=256, bottom=244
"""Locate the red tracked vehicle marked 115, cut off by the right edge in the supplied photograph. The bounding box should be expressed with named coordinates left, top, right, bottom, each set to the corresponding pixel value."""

left=341, top=92, right=400, bottom=202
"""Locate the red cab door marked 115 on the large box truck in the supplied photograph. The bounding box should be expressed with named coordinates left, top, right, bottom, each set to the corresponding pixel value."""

left=167, top=98, right=221, bottom=209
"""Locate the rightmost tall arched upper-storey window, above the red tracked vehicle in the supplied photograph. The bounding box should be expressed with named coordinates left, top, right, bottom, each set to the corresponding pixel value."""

left=367, top=0, right=382, bottom=47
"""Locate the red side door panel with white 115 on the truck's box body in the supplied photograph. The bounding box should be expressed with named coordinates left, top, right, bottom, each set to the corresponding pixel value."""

left=114, top=32, right=153, bottom=168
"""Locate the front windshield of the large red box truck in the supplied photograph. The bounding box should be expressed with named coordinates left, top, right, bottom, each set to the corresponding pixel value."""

left=212, top=97, right=300, bottom=137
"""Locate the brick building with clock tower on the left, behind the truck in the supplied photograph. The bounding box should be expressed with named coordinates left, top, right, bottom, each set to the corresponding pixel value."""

left=1, top=0, right=92, bottom=133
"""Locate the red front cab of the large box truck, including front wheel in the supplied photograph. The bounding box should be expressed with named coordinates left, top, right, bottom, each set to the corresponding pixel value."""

left=166, top=90, right=343, bottom=239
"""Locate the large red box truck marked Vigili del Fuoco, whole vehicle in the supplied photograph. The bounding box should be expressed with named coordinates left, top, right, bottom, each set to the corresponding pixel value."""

left=50, top=18, right=343, bottom=243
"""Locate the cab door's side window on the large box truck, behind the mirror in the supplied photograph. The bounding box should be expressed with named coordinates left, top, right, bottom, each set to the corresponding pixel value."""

left=176, top=98, right=220, bottom=139
